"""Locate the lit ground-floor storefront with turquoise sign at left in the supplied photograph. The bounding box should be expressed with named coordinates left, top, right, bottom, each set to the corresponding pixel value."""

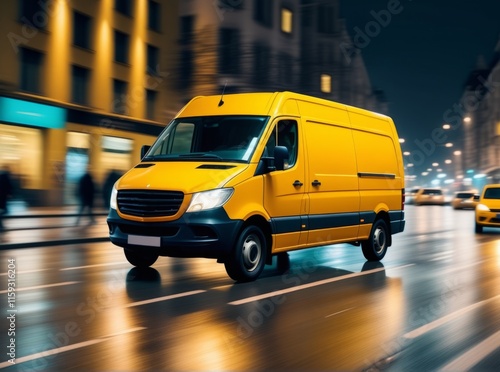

left=0, top=97, right=162, bottom=206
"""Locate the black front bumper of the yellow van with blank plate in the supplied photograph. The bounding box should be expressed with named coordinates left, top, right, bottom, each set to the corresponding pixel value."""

left=107, top=208, right=243, bottom=260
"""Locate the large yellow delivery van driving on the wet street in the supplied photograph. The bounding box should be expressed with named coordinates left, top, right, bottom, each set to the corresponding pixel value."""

left=107, top=92, right=405, bottom=281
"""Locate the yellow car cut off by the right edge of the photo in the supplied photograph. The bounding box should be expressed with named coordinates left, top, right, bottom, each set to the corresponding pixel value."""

left=476, top=184, right=500, bottom=233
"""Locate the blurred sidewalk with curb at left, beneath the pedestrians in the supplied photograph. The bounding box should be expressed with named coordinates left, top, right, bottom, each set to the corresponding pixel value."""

left=0, top=205, right=109, bottom=250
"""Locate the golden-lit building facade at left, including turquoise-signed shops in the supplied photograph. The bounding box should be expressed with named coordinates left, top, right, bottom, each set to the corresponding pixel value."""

left=0, top=0, right=180, bottom=205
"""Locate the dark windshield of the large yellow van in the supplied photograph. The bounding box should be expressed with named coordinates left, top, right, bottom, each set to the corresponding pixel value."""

left=143, top=115, right=269, bottom=162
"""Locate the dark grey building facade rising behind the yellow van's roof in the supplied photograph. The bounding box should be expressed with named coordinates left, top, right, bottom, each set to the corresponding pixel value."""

left=177, top=0, right=387, bottom=113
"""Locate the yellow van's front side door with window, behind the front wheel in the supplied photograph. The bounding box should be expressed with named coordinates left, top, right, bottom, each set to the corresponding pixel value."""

left=263, top=118, right=307, bottom=252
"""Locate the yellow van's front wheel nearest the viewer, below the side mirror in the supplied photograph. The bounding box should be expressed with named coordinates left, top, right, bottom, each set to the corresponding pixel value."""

left=224, top=225, right=267, bottom=282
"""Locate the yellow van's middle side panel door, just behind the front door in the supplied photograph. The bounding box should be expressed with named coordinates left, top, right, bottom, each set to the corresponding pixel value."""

left=304, top=121, right=360, bottom=245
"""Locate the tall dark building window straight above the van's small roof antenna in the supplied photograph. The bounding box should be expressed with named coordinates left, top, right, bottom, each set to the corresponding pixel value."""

left=219, top=28, right=241, bottom=75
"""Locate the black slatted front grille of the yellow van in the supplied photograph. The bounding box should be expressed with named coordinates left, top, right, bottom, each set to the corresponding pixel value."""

left=117, top=190, right=184, bottom=217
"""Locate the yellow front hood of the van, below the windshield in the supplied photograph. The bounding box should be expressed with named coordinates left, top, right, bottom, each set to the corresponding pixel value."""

left=117, top=161, right=248, bottom=194
